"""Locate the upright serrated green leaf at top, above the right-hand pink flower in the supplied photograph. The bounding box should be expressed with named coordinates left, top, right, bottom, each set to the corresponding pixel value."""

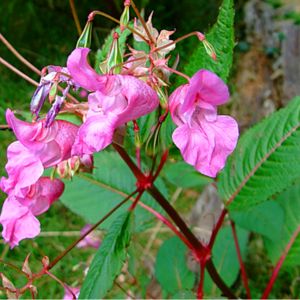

left=179, top=0, right=234, bottom=82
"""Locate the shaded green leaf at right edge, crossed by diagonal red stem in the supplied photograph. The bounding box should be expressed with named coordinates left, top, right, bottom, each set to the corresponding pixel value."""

left=265, top=185, right=300, bottom=267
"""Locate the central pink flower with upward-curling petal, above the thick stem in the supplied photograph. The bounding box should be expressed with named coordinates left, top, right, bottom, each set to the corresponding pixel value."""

left=67, top=48, right=159, bottom=155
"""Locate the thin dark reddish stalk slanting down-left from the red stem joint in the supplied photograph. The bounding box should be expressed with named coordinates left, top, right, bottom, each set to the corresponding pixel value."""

left=48, top=190, right=137, bottom=270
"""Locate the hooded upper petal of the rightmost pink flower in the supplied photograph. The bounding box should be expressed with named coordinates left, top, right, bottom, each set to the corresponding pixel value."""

left=182, top=70, right=229, bottom=113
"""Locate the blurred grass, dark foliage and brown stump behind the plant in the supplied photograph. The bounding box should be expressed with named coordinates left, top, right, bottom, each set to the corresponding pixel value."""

left=0, top=0, right=300, bottom=298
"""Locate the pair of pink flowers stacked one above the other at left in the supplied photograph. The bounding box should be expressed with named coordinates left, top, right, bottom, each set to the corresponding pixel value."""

left=0, top=110, right=78, bottom=248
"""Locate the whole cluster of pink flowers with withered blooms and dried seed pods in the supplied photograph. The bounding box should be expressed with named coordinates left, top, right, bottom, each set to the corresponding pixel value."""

left=0, top=8, right=238, bottom=247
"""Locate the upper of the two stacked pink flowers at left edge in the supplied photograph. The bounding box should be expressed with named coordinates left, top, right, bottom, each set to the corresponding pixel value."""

left=0, top=109, right=78, bottom=195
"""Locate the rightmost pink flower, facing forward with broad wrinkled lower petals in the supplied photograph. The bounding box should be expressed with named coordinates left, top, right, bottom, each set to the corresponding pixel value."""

left=169, top=70, right=239, bottom=177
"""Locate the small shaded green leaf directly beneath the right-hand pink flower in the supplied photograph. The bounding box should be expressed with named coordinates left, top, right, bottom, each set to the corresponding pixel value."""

left=163, top=161, right=213, bottom=188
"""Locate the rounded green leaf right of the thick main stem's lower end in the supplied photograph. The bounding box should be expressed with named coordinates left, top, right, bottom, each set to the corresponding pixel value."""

left=204, top=226, right=248, bottom=297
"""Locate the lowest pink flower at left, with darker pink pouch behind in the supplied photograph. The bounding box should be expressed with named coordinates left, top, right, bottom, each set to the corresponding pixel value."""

left=0, top=177, right=64, bottom=248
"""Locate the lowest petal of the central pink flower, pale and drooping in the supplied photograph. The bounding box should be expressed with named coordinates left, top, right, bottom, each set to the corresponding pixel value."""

left=72, top=115, right=116, bottom=156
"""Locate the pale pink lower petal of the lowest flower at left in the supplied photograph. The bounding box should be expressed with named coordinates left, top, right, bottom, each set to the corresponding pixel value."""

left=0, top=197, right=40, bottom=248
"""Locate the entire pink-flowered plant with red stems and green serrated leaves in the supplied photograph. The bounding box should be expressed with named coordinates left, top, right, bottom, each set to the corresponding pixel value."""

left=0, top=0, right=300, bottom=299
